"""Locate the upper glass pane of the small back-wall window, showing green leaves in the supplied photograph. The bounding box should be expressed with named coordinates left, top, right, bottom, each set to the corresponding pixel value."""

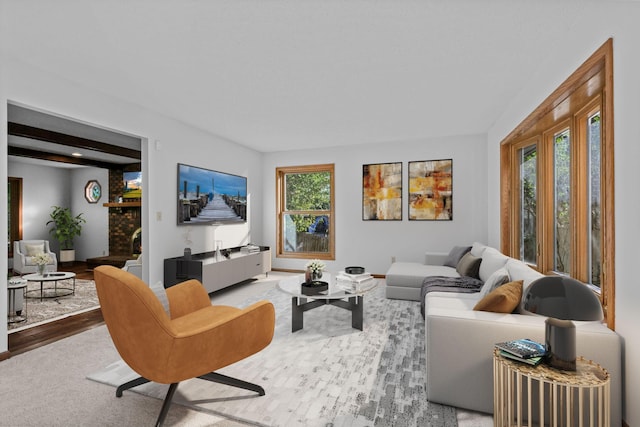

left=285, top=172, right=331, bottom=211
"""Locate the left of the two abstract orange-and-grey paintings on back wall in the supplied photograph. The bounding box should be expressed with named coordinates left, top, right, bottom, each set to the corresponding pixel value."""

left=362, top=162, right=402, bottom=221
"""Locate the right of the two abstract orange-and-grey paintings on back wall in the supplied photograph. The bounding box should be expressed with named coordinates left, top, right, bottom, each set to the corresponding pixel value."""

left=409, top=159, right=453, bottom=221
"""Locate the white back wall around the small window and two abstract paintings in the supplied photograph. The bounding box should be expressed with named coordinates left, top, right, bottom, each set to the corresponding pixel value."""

left=263, top=135, right=487, bottom=274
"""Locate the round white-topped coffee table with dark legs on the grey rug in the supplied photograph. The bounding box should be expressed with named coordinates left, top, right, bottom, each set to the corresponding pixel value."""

left=277, top=273, right=378, bottom=332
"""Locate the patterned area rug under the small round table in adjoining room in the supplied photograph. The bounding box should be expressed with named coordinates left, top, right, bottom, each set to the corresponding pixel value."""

left=8, top=279, right=99, bottom=331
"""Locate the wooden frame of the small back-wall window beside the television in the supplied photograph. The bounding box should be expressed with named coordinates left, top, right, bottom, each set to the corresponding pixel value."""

left=276, top=163, right=336, bottom=260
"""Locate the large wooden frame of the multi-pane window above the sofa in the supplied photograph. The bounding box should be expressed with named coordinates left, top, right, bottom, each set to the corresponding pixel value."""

left=500, top=39, right=615, bottom=330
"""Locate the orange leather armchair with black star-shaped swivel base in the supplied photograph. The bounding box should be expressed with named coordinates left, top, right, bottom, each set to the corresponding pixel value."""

left=94, top=266, right=275, bottom=426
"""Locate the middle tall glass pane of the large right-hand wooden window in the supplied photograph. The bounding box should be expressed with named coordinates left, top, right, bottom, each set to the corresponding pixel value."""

left=553, top=129, right=571, bottom=273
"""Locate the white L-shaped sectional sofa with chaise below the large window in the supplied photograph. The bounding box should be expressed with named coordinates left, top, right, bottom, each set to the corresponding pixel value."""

left=386, top=243, right=622, bottom=426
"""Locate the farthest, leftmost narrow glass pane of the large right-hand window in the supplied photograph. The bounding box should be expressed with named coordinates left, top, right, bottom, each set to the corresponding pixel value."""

left=518, top=145, right=538, bottom=265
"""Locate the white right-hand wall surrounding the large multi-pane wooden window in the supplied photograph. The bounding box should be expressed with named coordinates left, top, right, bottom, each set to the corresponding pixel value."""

left=488, top=2, right=640, bottom=426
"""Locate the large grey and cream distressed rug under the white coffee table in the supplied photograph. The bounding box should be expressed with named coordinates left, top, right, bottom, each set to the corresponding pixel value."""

left=88, top=286, right=457, bottom=427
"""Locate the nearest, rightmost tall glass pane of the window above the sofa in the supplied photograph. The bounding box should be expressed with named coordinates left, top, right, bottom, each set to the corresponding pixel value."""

left=587, top=112, right=602, bottom=287
